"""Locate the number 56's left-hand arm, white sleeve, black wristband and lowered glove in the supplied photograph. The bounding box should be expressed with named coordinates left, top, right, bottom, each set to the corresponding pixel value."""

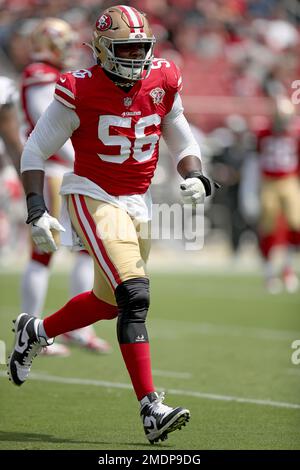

left=21, top=100, right=79, bottom=252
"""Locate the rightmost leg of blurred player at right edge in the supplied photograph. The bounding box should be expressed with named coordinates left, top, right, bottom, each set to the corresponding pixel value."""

left=281, top=176, right=300, bottom=293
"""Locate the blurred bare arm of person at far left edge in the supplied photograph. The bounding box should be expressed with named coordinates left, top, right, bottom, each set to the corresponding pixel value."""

left=0, top=103, right=23, bottom=173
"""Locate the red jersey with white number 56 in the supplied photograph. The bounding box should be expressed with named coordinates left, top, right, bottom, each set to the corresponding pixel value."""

left=54, top=59, right=181, bottom=196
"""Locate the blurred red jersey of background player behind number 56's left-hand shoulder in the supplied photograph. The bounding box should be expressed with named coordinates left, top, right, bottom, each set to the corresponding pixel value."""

left=21, top=62, right=66, bottom=164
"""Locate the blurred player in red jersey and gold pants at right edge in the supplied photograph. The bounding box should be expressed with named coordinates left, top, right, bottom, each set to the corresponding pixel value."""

left=257, top=97, right=300, bottom=294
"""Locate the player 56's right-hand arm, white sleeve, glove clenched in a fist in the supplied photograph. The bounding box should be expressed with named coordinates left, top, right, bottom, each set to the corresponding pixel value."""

left=162, top=93, right=216, bottom=204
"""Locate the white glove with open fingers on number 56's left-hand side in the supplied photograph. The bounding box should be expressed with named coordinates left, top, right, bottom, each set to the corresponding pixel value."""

left=31, top=212, right=65, bottom=253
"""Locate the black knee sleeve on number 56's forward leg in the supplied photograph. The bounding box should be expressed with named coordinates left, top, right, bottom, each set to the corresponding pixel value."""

left=115, top=277, right=150, bottom=344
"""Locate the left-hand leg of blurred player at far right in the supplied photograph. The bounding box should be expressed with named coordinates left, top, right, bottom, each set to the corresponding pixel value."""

left=259, top=180, right=282, bottom=294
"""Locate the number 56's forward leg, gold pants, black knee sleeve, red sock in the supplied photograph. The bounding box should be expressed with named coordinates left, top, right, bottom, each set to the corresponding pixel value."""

left=70, top=195, right=154, bottom=399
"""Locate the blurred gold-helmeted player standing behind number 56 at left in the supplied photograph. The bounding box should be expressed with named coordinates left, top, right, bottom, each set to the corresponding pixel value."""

left=21, top=18, right=111, bottom=355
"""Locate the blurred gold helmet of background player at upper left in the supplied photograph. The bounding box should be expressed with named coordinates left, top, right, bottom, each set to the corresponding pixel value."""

left=31, top=18, right=77, bottom=69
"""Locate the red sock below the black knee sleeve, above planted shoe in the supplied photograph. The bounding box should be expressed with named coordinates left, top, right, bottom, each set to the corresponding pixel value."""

left=120, top=343, right=155, bottom=400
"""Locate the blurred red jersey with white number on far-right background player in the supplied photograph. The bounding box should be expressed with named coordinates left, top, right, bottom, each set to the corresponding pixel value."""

left=257, top=128, right=300, bottom=178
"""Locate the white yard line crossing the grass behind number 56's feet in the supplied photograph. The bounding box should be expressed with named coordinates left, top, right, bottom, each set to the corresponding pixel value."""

left=0, top=371, right=300, bottom=410
